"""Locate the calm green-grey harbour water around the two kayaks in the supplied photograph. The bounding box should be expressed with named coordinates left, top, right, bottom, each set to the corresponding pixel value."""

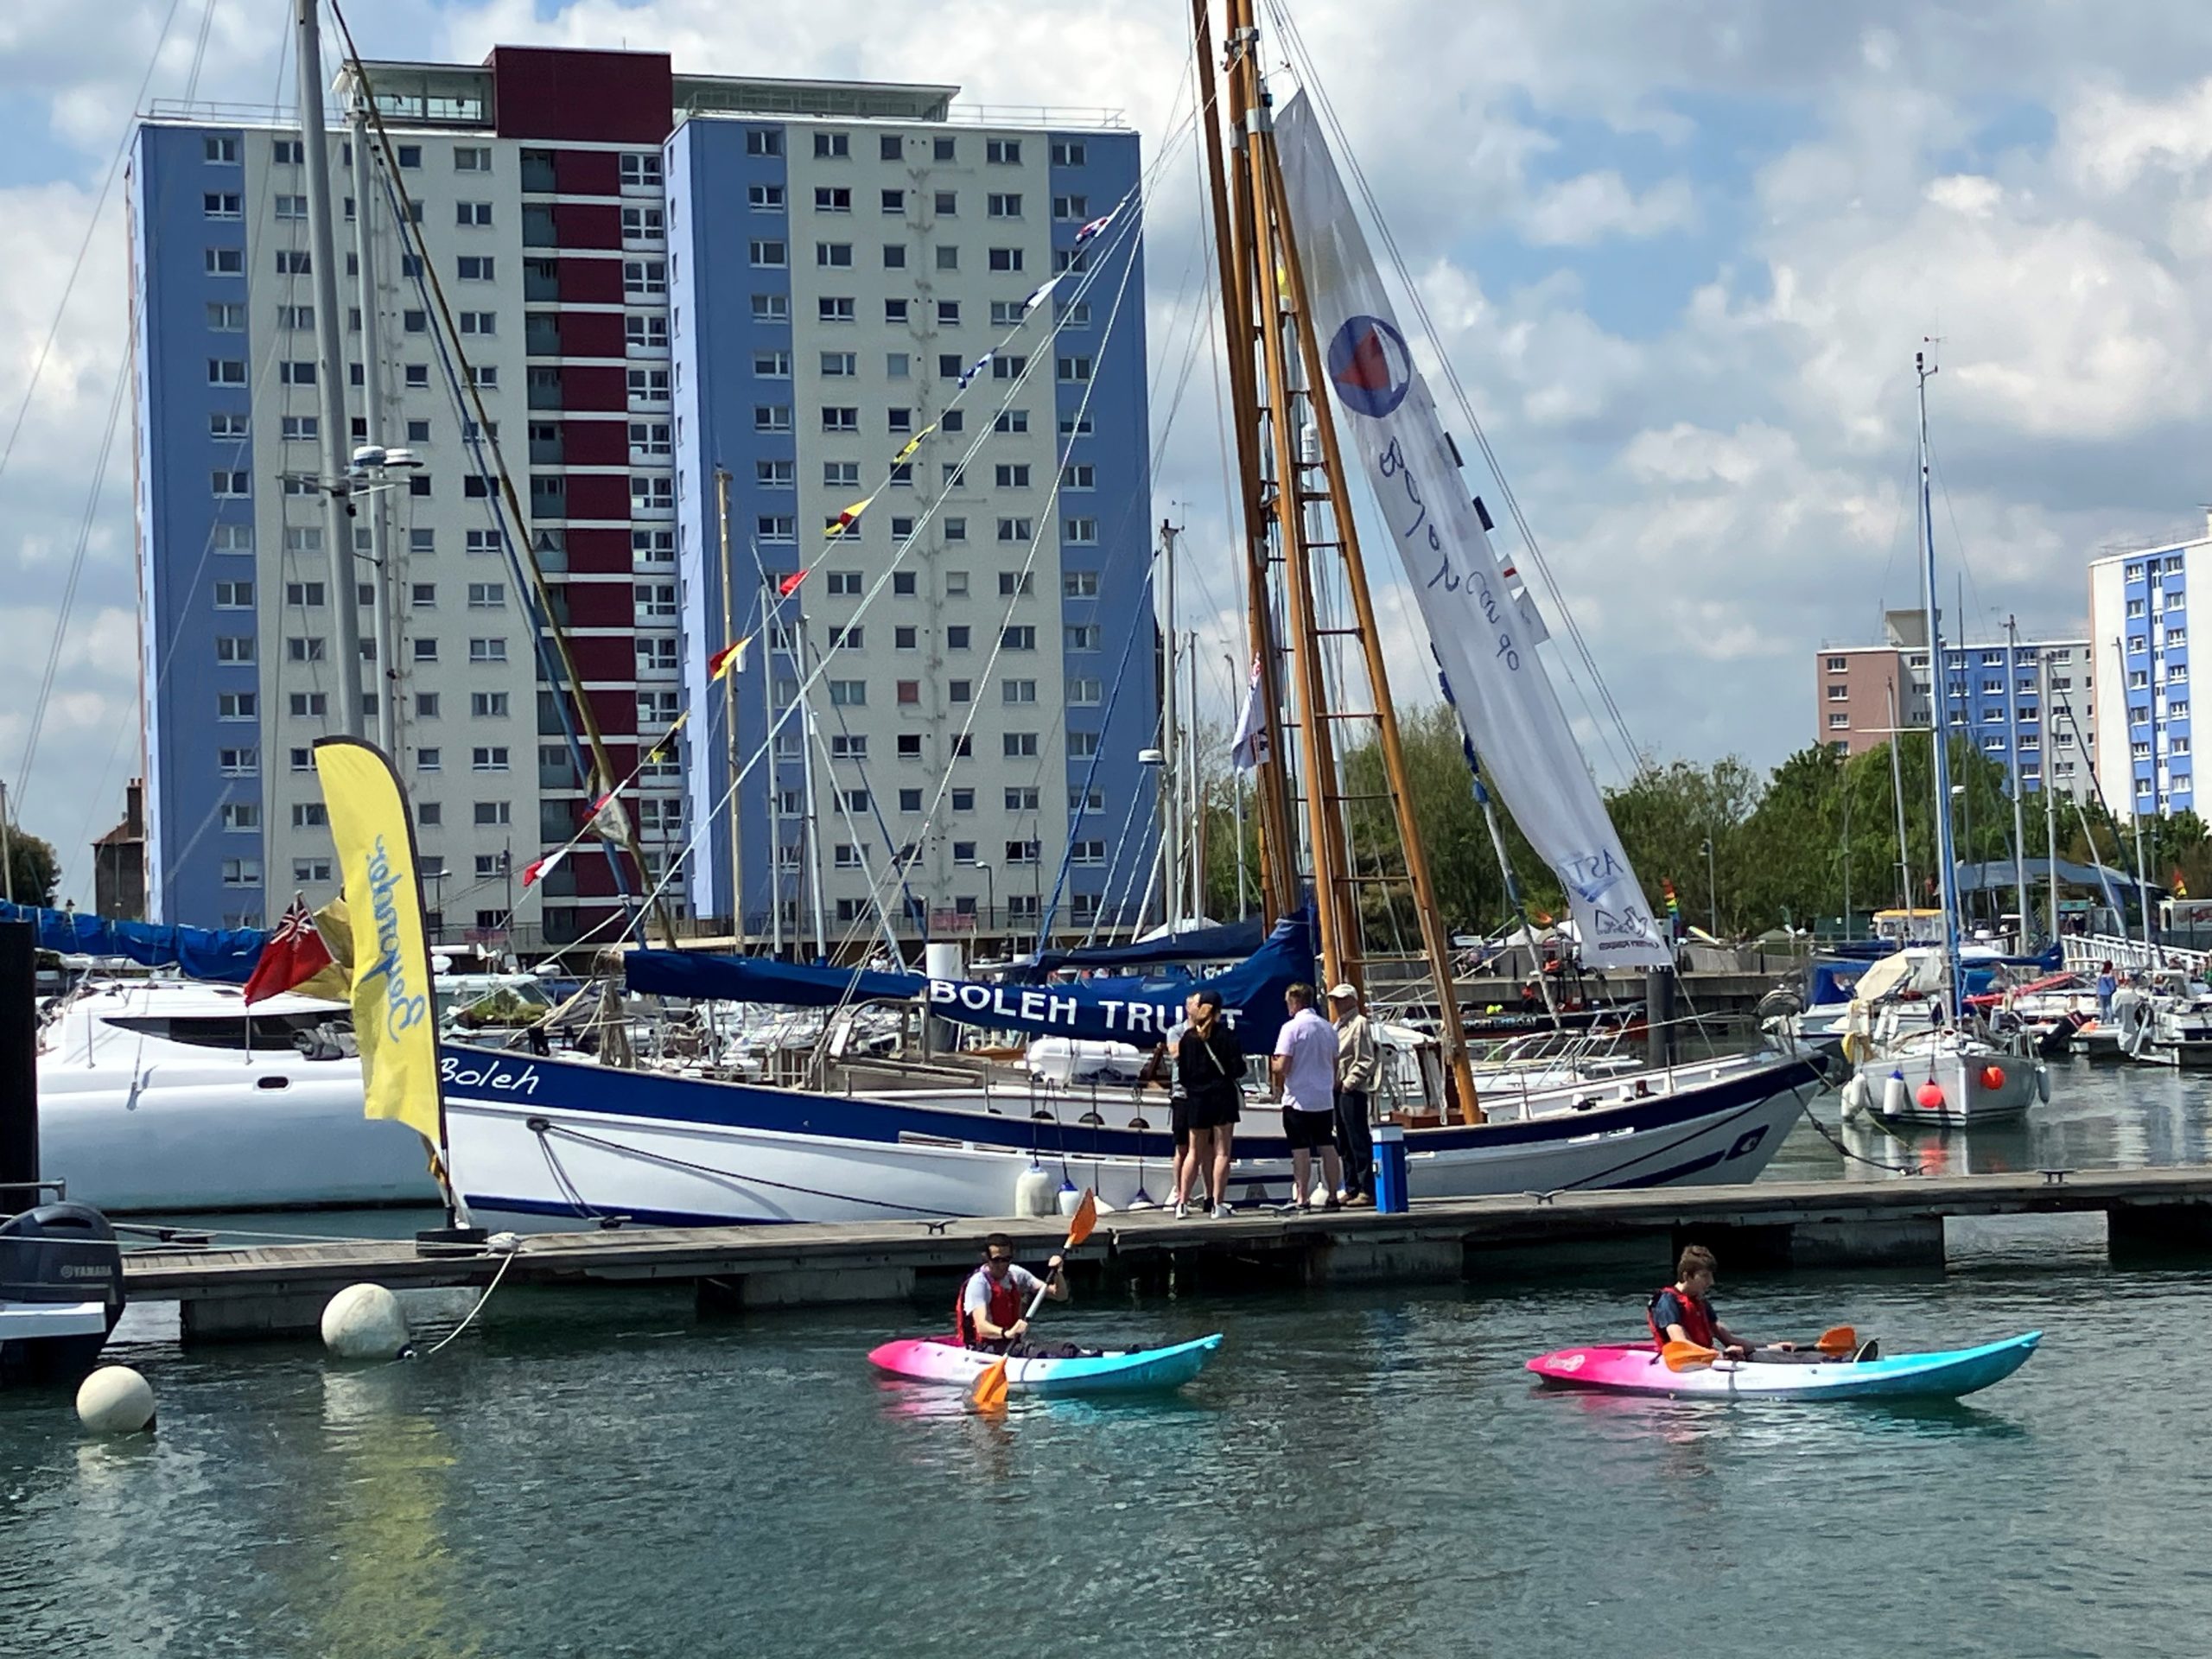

left=13, top=1071, right=2212, bottom=1659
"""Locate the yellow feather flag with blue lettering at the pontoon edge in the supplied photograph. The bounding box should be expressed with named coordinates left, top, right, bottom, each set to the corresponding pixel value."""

left=315, top=736, right=445, bottom=1146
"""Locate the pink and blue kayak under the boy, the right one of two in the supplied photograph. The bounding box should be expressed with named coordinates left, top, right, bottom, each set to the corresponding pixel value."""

left=1529, top=1332, right=2044, bottom=1400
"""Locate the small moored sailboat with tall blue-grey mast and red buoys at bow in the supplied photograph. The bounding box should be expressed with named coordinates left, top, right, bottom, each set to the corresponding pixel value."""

left=1845, top=352, right=2050, bottom=1126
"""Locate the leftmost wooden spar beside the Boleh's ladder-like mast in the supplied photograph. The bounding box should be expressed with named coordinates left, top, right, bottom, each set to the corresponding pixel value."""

left=1190, top=0, right=1299, bottom=920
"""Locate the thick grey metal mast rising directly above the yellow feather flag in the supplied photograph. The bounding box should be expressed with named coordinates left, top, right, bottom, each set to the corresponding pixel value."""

left=292, top=0, right=362, bottom=736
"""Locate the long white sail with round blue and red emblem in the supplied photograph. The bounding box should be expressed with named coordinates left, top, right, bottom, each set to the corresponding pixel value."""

left=1276, top=93, right=1672, bottom=967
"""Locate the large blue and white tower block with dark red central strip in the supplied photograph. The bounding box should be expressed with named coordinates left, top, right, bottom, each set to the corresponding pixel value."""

left=130, top=47, right=1157, bottom=944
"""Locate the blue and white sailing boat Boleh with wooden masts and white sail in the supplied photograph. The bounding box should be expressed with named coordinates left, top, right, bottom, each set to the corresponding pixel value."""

left=422, top=0, right=1825, bottom=1225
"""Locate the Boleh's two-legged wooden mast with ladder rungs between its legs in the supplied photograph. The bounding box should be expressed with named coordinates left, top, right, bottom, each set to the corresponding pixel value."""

left=1228, top=0, right=1480, bottom=1122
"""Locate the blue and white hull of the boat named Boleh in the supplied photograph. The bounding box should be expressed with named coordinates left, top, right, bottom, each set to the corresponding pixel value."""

left=442, top=1048, right=1822, bottom=1230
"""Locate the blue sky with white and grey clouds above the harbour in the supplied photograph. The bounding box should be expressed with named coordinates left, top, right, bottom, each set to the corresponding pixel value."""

left=0, top=0, right=2212, bottom=898
